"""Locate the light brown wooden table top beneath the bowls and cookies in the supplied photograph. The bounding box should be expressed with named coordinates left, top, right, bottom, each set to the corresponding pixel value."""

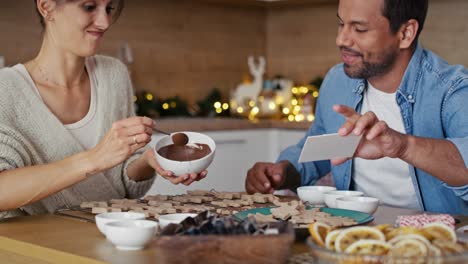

left=0, top=206, right=468, bottom=264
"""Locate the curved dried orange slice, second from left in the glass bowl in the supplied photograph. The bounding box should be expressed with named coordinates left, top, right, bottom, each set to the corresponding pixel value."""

left=335, top=226, right=385, bottom=252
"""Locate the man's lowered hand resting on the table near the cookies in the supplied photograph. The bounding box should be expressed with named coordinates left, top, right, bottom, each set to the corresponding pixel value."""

left=245, top=161, right=289, bottom=194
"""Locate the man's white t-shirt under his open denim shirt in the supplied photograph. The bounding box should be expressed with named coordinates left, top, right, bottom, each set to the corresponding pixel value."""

left=353, top=83, right=420, bottom=209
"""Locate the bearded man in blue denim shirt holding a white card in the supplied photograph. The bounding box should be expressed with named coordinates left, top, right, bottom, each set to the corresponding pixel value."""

left=246, top=0, right=468, bottom=214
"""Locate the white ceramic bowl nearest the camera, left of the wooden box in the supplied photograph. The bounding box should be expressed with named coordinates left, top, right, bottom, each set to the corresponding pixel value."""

left=106, top=220, right=158, bottom=250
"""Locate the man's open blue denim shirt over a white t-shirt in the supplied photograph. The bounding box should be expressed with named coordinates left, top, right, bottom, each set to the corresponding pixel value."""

left=278, top=45, right=468, bottom=215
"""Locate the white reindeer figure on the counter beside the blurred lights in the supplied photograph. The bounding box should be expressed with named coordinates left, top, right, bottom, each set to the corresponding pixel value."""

left=233, top=56, right=265, bottom=105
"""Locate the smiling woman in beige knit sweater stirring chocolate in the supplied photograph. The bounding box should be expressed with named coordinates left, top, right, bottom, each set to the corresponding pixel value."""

left=0, top=0, right=207, bottom=218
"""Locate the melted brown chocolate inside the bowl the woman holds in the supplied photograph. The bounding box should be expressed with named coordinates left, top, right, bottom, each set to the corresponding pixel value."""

left=158, top=143, right=211, bottom=161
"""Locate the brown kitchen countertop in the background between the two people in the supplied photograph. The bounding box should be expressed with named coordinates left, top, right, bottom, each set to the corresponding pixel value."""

left=156, top=118, right=311, bottom=132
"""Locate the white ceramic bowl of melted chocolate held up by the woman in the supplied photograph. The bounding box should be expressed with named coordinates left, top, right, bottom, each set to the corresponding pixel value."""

left=154, top=131, right=216, bottom=176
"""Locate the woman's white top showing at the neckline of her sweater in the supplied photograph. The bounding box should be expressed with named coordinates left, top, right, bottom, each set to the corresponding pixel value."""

left=14, top=60, right=99, bottom=149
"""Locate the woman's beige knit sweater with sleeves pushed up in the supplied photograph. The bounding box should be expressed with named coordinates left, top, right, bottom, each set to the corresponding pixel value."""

left=0, top=56, right=155, bottom=219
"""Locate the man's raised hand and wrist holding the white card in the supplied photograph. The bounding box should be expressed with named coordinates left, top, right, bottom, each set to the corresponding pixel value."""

left=331, top=105, right=407, bottom=165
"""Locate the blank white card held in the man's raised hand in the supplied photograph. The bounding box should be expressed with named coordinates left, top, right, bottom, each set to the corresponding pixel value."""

left=299, top=134, right=361, bottom=162
